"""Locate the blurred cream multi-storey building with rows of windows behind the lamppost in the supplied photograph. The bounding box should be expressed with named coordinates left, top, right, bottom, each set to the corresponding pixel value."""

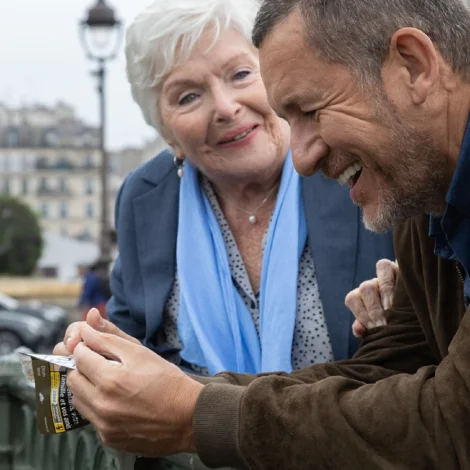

left=0, top=103, right=122, bottom=241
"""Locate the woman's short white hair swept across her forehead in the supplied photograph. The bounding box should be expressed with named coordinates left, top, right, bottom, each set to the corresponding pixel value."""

left=126, top=0, right=259, bottom=132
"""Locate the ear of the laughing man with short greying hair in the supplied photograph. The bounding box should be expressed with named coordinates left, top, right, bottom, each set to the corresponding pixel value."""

left=384, top=28, right=439, bottom=105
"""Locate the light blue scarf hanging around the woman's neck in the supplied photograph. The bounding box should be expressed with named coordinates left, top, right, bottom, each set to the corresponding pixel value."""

left=176, top=152, right=307, bottom=374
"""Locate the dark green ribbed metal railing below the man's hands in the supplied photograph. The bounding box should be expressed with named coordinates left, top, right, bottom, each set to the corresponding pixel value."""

left=0, top=355, right=227, bottom=470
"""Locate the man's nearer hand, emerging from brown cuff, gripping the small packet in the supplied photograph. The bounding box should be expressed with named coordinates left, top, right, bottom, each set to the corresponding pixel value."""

left=67, top=325, right=203, bottom=457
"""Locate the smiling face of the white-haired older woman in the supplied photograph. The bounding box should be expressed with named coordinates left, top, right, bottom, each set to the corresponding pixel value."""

left=160, top=29, right=290, bottom=184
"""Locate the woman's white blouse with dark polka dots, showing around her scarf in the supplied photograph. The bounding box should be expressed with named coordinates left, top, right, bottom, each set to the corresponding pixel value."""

left=161, top=178, right=334, bottom=375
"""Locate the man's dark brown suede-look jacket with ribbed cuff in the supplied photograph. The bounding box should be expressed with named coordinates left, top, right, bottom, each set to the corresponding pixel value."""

left=194, top=216, right=470, bottom=470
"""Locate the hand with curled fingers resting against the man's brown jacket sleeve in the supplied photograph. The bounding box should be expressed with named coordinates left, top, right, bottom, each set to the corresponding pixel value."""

left=345, top=259, right=398, bottom=338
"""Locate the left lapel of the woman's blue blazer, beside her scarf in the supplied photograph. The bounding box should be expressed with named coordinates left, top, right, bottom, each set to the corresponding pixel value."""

left=134, top=167, right=179, bottom=331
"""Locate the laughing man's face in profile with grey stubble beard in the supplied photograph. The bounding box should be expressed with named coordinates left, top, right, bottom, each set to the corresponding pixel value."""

left=260, top=13, right=446, bottom=231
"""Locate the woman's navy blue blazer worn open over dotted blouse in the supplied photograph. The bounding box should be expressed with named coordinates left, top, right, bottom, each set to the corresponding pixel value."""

left=107, top=150, right=395, bottom=360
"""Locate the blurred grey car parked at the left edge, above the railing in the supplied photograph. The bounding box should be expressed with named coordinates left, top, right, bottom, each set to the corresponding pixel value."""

left=0, top=293, right=68, bottom=354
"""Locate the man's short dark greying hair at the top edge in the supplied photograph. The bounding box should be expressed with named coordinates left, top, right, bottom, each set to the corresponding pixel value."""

left=252, top=0, right=470, bottom=84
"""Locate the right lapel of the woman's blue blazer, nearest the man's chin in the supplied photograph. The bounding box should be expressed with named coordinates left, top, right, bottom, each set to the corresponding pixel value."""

left=302, top=173, right=359, bottom=360
